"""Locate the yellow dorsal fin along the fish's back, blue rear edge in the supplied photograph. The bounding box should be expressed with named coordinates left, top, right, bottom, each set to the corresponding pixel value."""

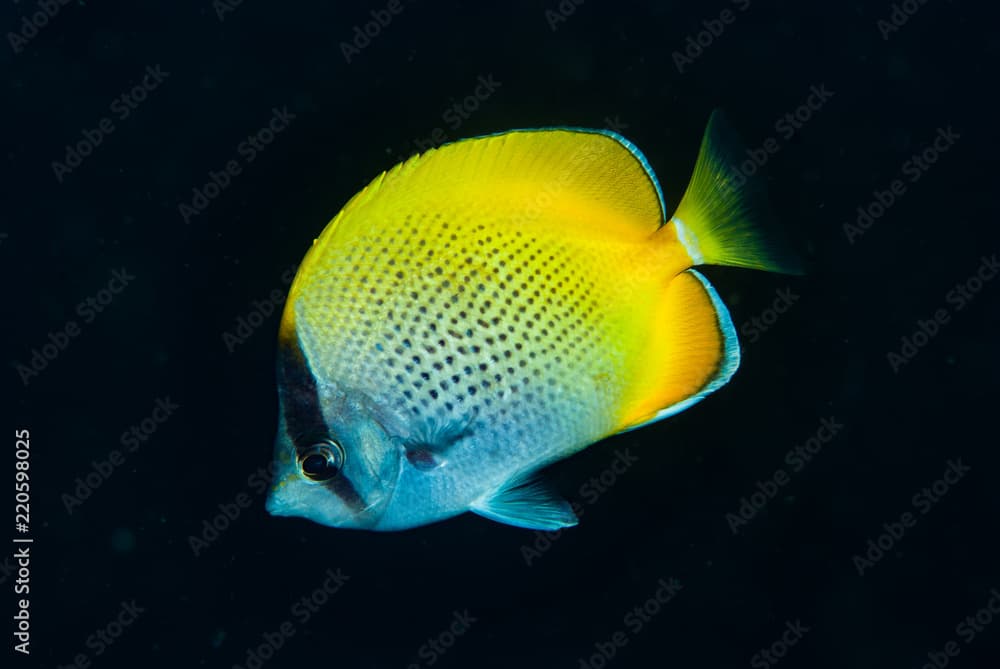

left=281, top=128, right=664, bottom=338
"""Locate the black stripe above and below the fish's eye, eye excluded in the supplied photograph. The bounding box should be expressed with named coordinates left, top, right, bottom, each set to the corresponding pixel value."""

left=278, top=337, right=366, bottom=513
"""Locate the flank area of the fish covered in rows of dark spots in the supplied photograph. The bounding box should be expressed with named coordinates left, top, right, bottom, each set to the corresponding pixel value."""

left=294, top=214, right=632, bottom=455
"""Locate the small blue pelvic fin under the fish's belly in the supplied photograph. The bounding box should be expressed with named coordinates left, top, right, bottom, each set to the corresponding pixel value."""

left=469, top=478, right=577, bottom=530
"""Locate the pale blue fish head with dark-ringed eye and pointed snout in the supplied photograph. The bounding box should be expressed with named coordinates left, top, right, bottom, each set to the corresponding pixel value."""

left=267, top=376, right=402, bottom=529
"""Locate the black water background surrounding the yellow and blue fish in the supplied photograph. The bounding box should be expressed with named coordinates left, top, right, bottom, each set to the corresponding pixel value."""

left=0, top=0, right=1000, bottom=669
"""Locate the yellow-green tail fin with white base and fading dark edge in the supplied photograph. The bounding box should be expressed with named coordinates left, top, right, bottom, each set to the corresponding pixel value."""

left=671, top=110, right=802, bottom=274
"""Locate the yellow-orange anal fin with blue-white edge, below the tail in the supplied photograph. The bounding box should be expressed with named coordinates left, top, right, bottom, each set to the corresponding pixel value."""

left=618, top=269, right=740, bottom=431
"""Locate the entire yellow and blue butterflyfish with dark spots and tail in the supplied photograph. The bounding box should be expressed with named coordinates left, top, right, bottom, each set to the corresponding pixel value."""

left=267, top=114, right=797, bottom=530
